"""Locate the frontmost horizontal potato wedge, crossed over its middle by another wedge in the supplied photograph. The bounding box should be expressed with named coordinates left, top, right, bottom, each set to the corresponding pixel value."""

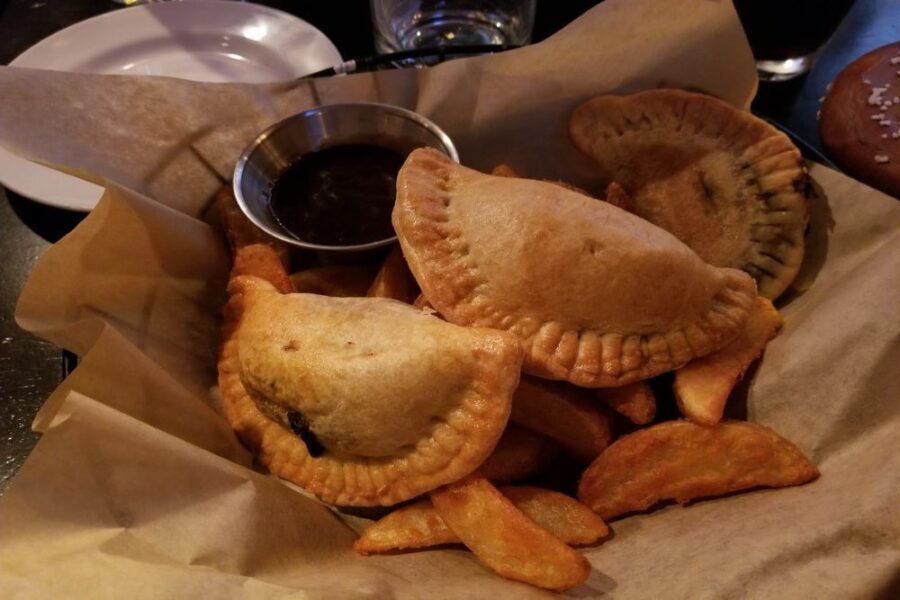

left=353, top=486, right=609, bottom=554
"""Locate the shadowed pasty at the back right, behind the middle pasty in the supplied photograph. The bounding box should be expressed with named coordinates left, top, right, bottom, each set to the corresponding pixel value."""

left=569, top=90, right=810, bottom=299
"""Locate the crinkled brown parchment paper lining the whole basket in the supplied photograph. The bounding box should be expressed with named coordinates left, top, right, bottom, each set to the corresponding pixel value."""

left=0, top=0, right=900, bottom=598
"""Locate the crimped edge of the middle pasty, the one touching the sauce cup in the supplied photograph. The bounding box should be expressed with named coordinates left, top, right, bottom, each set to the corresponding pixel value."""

left=393, top=148, right=756, bottom=387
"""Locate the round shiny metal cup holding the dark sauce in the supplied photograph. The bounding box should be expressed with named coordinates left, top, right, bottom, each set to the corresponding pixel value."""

left=234, top=102, right=459, bottom=253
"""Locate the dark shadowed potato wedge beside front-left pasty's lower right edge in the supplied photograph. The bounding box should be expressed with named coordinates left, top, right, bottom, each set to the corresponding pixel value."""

left=478, top=424, right=558, bottom=482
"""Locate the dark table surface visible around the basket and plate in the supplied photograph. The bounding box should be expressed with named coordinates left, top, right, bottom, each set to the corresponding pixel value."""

left=0, top=0, right=900, bottom=494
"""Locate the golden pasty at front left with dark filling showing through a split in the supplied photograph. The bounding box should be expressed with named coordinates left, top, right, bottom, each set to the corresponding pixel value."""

left=219, top=276, right=522, bottom=506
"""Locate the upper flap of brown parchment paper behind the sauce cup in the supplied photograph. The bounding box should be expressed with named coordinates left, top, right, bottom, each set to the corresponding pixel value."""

left=0, top=0, right=756, bottom=215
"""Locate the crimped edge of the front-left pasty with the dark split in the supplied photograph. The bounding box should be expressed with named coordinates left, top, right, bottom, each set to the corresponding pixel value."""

left=218, top=277, right=521, bottom=506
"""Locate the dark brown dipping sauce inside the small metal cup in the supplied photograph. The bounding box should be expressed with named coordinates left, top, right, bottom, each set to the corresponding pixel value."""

left=269, top=144, right=406, bottom=246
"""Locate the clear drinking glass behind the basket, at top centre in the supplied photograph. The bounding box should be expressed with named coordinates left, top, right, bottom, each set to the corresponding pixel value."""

left=371, top=0, right=535, bottom=54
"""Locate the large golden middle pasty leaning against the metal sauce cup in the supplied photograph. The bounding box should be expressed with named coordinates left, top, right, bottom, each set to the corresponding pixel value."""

left=392, top=148, right=756, bottom=387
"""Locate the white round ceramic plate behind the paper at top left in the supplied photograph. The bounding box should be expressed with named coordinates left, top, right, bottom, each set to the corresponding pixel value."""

left=0, top=0, right=341, bottom=211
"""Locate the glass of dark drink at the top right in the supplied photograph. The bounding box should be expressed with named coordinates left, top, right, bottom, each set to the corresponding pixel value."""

left=734, top=0, right=853, bottom=81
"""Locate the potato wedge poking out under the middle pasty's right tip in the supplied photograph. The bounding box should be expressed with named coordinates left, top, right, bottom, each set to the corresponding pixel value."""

left=674, top=296, right=782, bottom=425
